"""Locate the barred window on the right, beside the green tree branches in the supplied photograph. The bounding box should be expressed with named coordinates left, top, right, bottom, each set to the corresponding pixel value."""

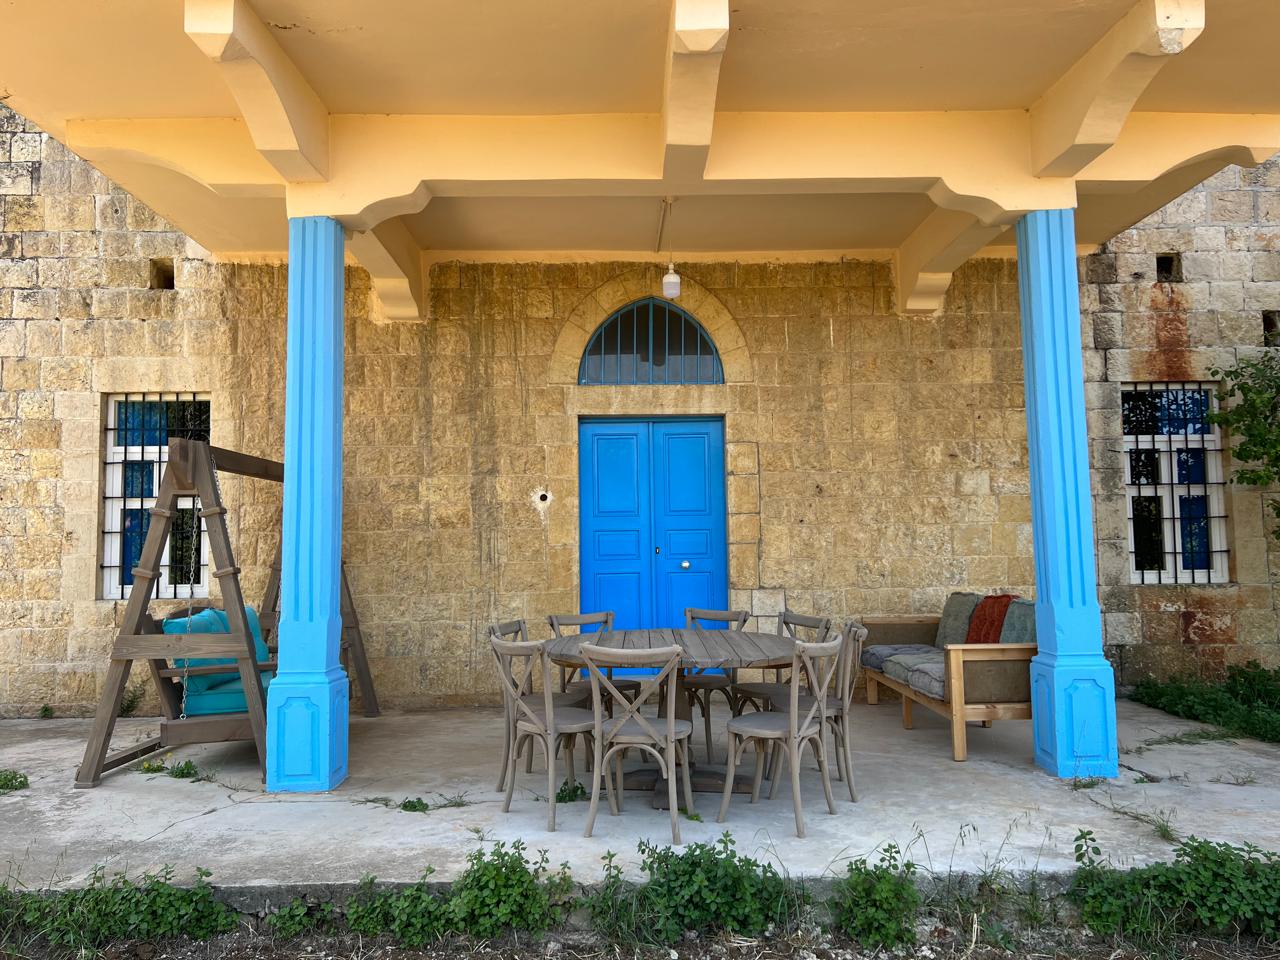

left=1120, top=381, right=1228, bottom=584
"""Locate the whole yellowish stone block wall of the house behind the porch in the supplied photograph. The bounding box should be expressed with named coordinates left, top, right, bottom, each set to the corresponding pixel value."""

left=0, top=109, right=1277, bottom=716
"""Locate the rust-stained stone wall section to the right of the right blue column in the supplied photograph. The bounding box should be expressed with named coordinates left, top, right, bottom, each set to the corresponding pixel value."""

left=1082, top=159, right=1280, bottom=684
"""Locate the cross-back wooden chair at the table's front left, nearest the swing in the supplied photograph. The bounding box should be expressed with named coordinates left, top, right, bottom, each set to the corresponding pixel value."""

left=489, top=632, right=594, bottom=831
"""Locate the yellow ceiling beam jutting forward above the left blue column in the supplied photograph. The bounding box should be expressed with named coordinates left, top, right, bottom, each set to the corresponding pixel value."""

left=183, top=0, right=329, bottom=182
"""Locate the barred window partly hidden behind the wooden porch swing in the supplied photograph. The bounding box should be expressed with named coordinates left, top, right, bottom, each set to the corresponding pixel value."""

left=101, top=393, right=209, bottom=600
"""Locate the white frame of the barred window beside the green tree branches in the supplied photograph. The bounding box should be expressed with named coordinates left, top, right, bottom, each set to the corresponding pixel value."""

left=1120, top=380, right=1230, bottom=585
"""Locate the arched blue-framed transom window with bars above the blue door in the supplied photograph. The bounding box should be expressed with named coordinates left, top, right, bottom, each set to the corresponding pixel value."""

left=577, top=297, right=724, bottom=385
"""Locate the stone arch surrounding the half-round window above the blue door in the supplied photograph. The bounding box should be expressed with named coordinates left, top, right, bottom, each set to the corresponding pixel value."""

left=549, top=264, right=753, bottom=385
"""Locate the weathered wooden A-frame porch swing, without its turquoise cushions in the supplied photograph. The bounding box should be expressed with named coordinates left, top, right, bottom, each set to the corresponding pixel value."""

left=76, top=439, right=379, bottom=787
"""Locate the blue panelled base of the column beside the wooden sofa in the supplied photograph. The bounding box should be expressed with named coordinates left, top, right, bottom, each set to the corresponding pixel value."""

left=1032, top=652, right=1120, bottom=778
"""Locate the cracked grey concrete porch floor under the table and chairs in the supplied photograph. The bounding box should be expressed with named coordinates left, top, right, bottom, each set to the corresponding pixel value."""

left=0, top=701, right=1280, bottom=886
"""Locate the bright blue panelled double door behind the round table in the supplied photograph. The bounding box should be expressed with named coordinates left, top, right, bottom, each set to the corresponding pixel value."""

left=579, top=419, right=728, bottom=630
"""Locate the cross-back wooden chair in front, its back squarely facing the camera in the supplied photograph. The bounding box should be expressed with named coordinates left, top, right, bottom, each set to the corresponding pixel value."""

left=579, top=644, right=694, bottom=844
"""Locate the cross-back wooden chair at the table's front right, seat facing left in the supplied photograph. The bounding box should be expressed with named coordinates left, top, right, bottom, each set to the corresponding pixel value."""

left=718, top=634, right=844, bottom=837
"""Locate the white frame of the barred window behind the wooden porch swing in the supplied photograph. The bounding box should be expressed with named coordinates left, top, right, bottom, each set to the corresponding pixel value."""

left=100, top=392, right=210, bottom=600
